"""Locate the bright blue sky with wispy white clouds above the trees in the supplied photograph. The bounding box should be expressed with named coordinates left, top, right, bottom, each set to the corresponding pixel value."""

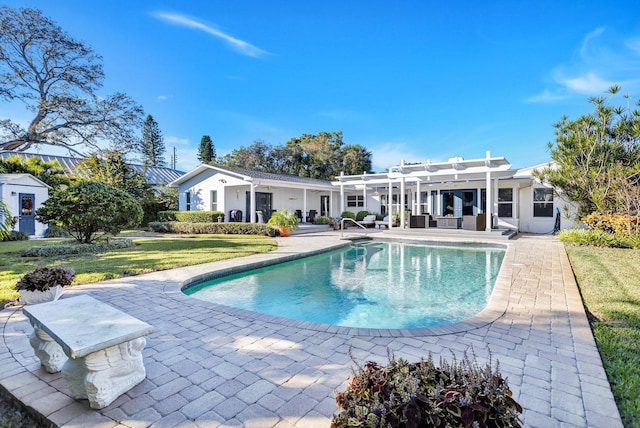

left=0, top=0, right=640, bottom=172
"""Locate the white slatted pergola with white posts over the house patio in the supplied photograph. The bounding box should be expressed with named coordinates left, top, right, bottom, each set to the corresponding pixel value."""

left=332, top=151, right=514, bottom=230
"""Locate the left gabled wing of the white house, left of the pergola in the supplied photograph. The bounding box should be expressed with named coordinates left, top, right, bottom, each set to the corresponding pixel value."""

left=169, top=164, right=341, bottom=223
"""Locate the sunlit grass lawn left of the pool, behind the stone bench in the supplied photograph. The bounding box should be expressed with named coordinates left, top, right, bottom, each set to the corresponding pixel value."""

left=0, top=235, right=277, bottom=307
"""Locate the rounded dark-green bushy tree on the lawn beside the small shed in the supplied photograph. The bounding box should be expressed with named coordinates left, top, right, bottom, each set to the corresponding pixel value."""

left=36, top=182, right=142, bottom=244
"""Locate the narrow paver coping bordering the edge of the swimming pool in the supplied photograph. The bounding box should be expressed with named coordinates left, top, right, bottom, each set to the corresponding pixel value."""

left=172, top=237, right=514, bottom=337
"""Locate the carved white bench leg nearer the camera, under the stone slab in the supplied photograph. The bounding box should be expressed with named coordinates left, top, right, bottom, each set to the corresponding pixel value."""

left=62, top=337, right=147, bottom=409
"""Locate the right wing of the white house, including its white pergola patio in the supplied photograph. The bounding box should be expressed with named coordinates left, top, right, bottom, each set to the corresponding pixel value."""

left=332, top=151, right=572, bottom=233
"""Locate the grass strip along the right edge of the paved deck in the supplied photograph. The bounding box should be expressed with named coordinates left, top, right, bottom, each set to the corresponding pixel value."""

left=567, top=246, right=640, bottom=427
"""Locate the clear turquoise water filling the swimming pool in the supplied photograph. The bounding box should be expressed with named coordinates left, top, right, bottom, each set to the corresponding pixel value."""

left=184, top=242, right=505, bottom=329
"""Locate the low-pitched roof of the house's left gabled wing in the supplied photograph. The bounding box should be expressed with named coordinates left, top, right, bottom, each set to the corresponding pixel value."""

left=169, top=164, right=332, bottom=188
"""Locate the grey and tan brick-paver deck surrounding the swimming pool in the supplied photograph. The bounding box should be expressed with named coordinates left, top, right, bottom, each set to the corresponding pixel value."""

left=0, top=230, right=622, bottom=428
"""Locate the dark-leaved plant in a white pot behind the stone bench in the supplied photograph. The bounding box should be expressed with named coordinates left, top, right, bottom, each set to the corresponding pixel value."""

left=16, top=267, right=76, bottom=305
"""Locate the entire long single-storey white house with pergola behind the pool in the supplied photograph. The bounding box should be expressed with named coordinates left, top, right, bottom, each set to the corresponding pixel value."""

left=170, top=152, right=575, bottom=233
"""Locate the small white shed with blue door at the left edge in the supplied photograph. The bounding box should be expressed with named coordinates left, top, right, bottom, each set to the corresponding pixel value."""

left=0, top=174, right=49, bottom=236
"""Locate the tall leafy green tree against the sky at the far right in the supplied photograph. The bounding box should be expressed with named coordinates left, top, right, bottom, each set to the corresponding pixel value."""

left=534, top=86, right=640, bottom=216
